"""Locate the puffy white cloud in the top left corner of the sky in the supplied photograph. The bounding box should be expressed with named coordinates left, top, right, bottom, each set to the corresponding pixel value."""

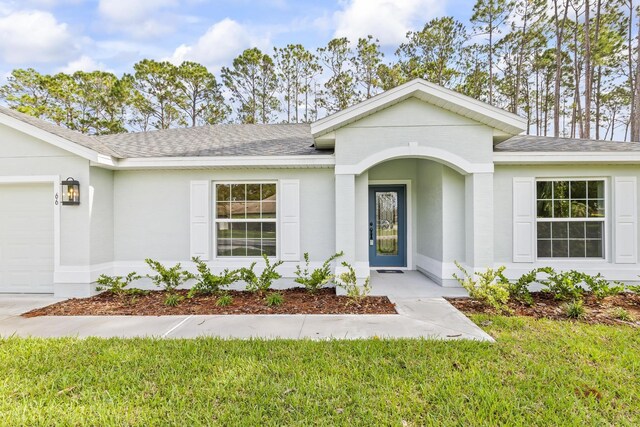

left=0, top=10, right=77, bottom=64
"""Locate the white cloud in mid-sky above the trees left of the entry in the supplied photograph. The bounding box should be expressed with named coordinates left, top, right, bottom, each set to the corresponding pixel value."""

left=169, top=18, right=270, bottom=71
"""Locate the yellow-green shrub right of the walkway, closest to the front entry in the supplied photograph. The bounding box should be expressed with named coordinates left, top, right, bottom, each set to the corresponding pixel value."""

left=453, top=261, right=510, bottom=313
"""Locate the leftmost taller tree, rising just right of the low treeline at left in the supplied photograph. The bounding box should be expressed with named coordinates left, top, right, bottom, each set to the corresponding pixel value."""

left=133, top=59, right=186, bottom=129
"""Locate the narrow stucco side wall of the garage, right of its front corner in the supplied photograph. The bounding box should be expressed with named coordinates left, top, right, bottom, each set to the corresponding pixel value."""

left=88, top=167, right=114, bottom=264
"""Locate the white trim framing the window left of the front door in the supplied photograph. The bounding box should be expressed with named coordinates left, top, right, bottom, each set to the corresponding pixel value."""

left=211, top=179, right=280, bottom=262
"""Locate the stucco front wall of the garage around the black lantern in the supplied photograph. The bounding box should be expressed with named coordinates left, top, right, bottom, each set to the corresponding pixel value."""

left=0, top=125, right=90, bottom=266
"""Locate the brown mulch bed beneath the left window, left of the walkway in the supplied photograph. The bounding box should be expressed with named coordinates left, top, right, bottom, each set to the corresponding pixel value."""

left=23, top=288, right=397, bottom=317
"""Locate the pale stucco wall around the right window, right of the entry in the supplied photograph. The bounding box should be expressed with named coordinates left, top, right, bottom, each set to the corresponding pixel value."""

left=494, top=165, right=640, bottom=280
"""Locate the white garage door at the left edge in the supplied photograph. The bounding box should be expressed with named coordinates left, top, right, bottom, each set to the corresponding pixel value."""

left=0, top=184, right=53, bottom=293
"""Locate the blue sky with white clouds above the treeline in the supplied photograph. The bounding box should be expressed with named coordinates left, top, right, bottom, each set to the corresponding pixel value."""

left=0, top=0, right=474, bottom=80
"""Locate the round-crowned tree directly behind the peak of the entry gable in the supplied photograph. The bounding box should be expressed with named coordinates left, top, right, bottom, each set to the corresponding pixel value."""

left=396, top=16, right=466, bottom=87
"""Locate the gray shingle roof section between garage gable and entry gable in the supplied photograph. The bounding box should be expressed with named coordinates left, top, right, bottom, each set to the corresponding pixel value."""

left=97, top=124, right=326, bottom=157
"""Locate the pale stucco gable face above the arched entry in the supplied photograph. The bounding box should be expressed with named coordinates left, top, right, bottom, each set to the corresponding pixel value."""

left=335, top=98, right=493, bottom=165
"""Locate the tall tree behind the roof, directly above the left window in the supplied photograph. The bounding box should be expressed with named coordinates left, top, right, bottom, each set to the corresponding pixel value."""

left=221, top=48, right=280, bottom=123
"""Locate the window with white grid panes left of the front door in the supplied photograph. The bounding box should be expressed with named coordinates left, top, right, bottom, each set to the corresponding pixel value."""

left=215, top=183, right=276, bottom=257
